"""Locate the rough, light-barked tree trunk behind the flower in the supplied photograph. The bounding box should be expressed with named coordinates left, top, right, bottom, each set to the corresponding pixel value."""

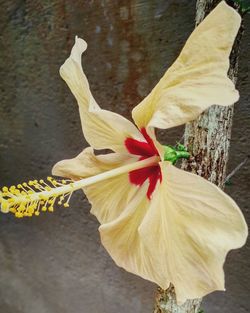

left=154, top=0, right=243, bottom=313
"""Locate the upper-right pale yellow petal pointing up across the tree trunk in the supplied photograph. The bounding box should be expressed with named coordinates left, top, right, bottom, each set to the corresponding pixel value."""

left=132, top=1, right=241, bottom=128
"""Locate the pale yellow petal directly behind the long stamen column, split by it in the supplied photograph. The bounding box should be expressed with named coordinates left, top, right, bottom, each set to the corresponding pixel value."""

left=52, top=148, right=138, bottom=223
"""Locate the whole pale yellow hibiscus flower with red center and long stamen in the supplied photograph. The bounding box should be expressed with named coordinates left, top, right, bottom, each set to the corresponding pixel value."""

left=2, top=1, right=247, bottom=302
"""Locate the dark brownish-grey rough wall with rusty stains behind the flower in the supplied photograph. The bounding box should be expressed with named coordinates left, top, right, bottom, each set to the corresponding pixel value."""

left=0, top=0, right=250, bottom=313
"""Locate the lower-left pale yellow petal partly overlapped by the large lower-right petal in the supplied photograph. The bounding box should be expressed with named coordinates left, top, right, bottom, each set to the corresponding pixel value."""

left=99, top=183, right=170, bottom=286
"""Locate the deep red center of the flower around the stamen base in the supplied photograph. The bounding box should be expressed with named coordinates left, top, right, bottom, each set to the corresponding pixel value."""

left=125, top=128, right=162, bottom=200
